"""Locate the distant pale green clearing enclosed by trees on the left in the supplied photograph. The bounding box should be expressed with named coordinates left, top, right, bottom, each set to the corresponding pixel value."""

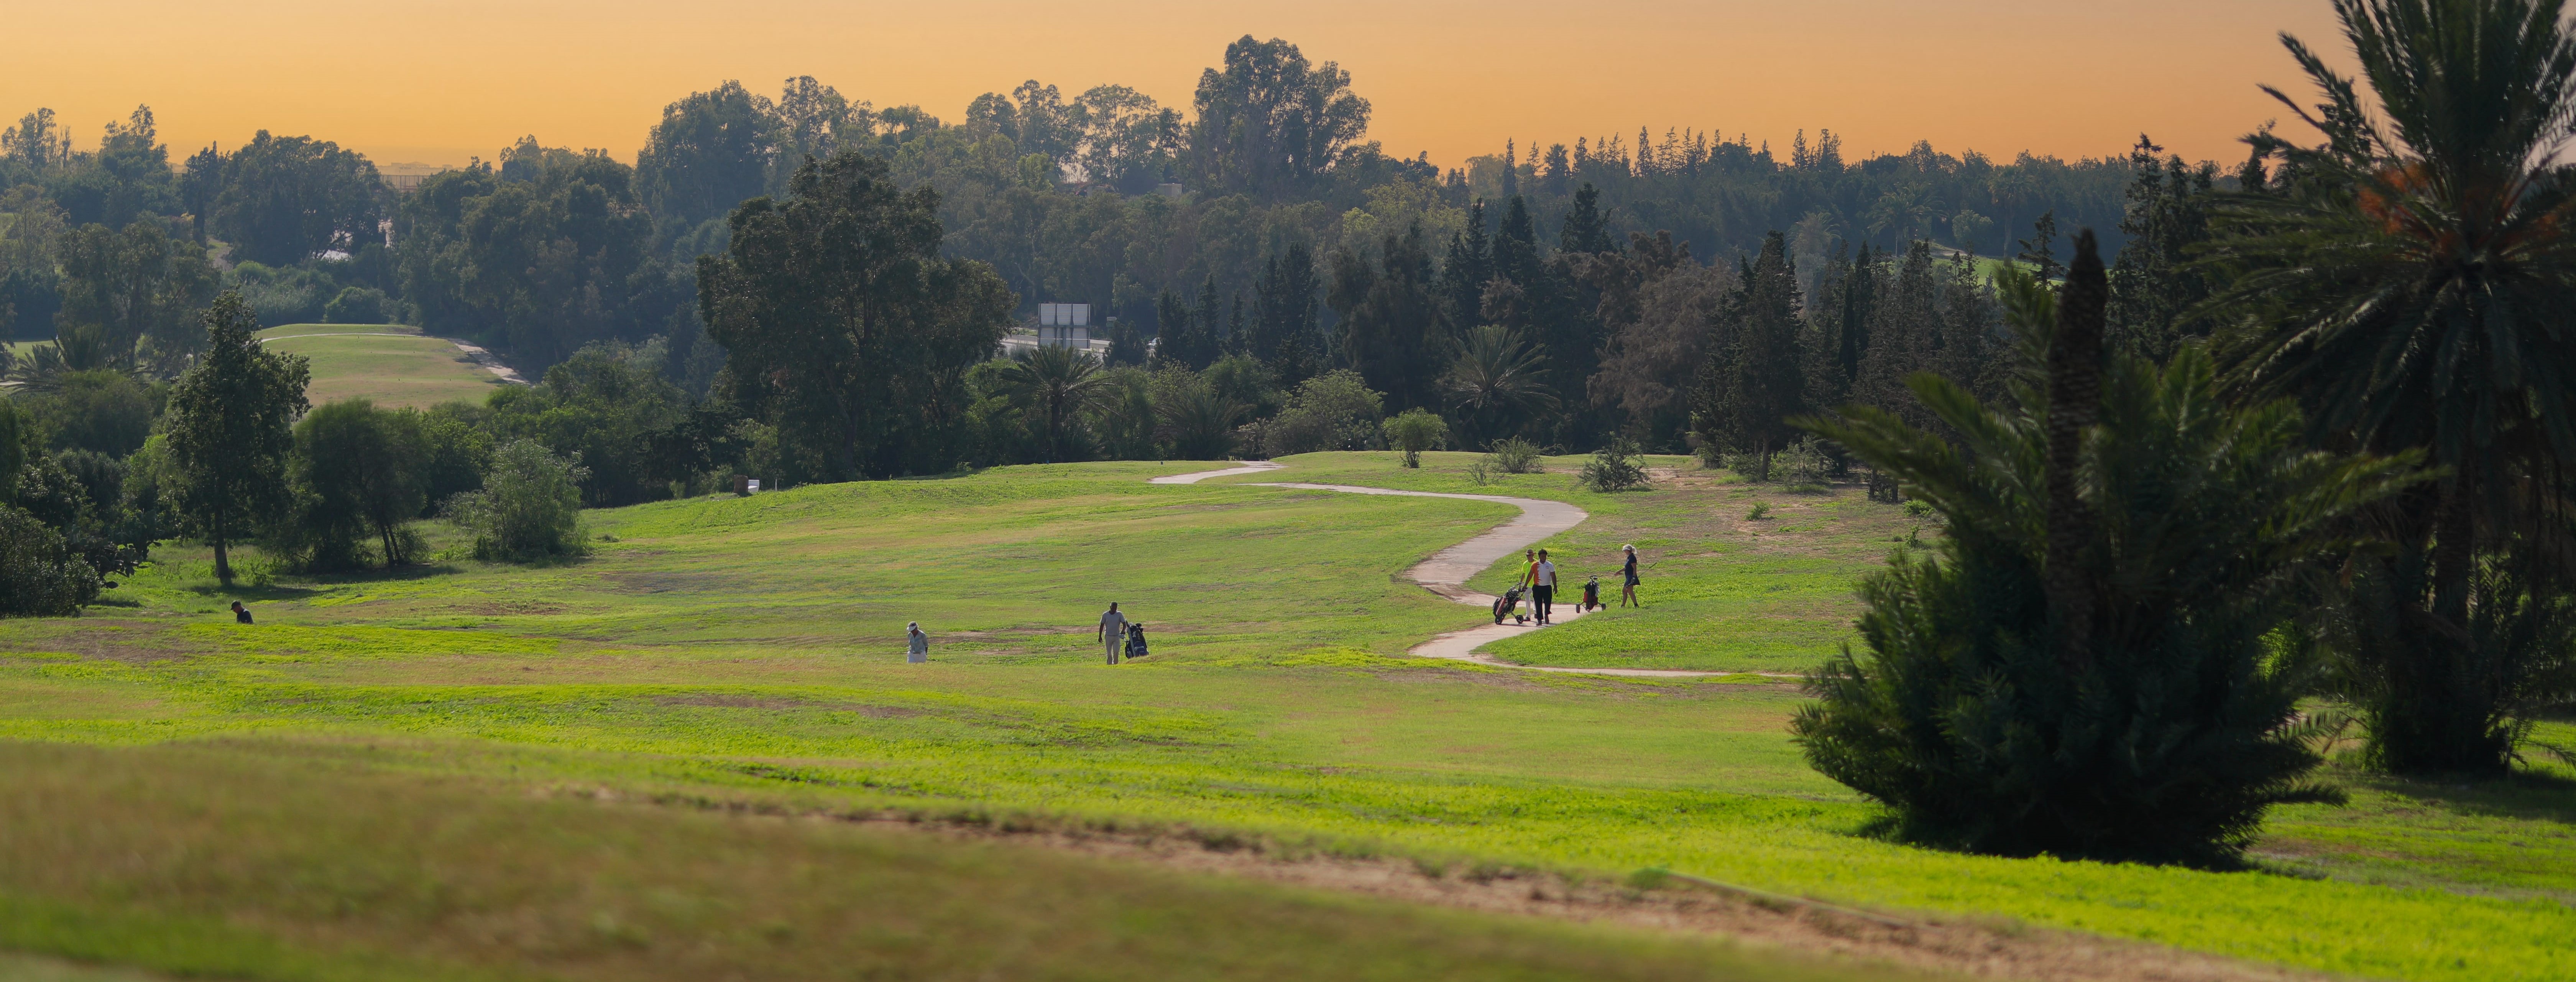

left=260, top=325, right=508, bottom=407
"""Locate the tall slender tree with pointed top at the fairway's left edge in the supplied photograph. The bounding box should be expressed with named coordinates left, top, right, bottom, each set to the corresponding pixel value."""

left=162, top=291, right=312, bottom=585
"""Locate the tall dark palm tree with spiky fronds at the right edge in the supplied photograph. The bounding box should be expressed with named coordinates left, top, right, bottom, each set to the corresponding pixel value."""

left=2210, top=0, right=2576, bottom=771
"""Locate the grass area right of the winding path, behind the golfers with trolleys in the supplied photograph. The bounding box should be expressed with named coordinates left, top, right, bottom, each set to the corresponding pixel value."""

left=1221, top=454, right=1922, bottom=673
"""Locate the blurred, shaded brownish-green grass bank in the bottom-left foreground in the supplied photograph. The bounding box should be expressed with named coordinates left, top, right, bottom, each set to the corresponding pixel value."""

left=0, top=745, right=1899, bottom=982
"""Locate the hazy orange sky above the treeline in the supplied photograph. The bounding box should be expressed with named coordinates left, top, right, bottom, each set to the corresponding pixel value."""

left=0, top=0, right=2341, bottom=165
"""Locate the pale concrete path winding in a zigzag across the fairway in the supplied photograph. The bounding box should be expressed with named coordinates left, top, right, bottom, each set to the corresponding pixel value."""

left=1152, top=461, right=1731, bottom=678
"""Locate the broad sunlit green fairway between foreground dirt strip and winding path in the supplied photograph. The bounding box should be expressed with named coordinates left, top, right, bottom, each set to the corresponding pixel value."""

left=0, top=454, right=2576, bottom=979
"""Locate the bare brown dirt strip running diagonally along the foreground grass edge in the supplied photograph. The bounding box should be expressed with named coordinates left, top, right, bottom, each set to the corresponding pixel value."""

left=866, top=820, right=2331, bottom=982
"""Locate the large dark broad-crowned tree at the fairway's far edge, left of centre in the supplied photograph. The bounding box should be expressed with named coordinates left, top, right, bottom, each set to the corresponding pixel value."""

left=698, top=152, right=1017, bottom=479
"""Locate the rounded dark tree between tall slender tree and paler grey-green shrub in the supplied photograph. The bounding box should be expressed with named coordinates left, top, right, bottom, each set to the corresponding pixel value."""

left=291, top=400, right=428, bottom=567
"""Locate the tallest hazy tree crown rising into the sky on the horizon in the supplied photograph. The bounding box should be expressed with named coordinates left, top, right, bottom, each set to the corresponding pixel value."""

left=1190, top=33, right=1368, bottom=201
